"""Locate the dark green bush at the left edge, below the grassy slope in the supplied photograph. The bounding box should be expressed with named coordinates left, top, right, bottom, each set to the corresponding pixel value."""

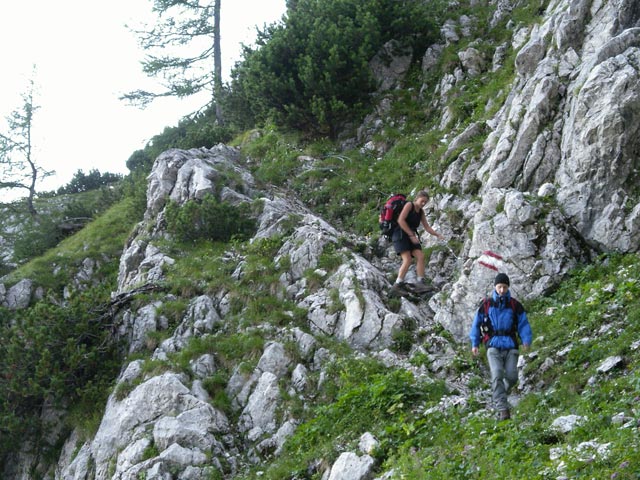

left=0, top=284, right=121, bottom=454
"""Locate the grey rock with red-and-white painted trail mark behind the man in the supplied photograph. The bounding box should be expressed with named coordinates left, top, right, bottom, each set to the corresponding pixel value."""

left=431, top=189, right=586, bottom=340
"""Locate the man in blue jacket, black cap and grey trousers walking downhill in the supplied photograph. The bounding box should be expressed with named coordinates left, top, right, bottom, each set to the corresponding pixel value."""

left=469, top=273, right=533, bottom=420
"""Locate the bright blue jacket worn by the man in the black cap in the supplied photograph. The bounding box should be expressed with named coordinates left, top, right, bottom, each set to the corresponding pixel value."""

left=469, top=290, right=533, bottom=349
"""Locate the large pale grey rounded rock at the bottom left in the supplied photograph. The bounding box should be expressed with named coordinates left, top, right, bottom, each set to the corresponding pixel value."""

left=59, top=370, right=229, bottom=480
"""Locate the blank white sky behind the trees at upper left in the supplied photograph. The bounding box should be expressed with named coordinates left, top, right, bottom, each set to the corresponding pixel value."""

left=0, top=0, right=285, bottom=201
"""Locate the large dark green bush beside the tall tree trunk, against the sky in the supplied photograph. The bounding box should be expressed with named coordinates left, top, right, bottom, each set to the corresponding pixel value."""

left=226, top=0, right=440, bottom=137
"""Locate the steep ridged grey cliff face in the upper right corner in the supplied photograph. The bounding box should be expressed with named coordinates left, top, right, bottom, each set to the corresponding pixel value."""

left=478, top=0, right=640, bottom=252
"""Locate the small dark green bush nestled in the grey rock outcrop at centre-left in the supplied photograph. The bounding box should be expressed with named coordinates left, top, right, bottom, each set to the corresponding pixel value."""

left=166, top=194, right=256, bottom=242
